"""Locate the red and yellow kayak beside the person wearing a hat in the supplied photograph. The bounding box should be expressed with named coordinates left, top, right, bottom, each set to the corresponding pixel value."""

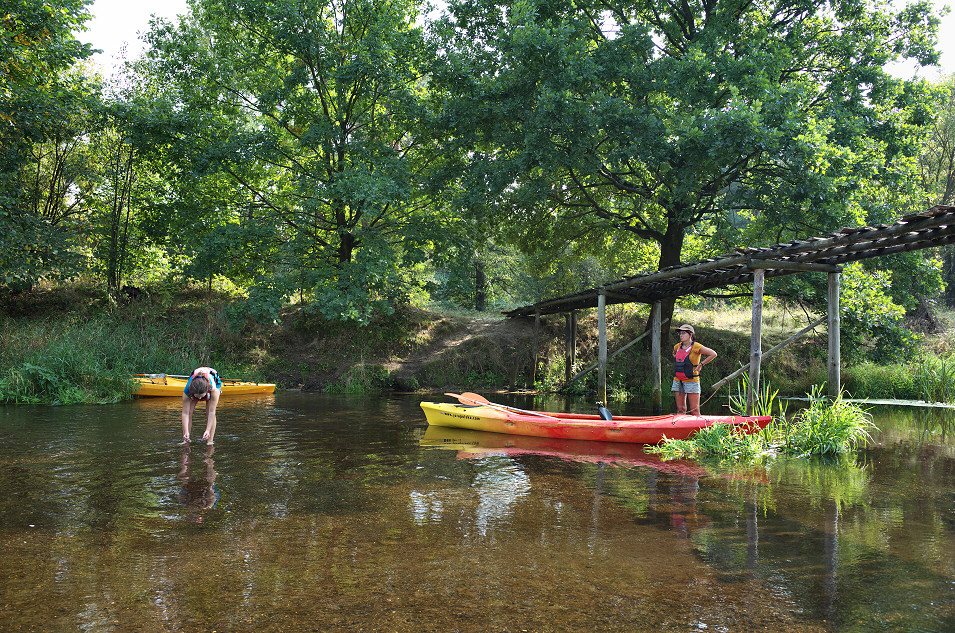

left=421, top=402, right=772, bottom=444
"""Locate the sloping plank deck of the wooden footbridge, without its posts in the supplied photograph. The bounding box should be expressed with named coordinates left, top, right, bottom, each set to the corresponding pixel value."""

left=505, top=206, right=955, bottom=317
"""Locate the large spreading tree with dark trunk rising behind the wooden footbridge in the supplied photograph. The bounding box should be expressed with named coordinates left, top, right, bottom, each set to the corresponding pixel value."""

left=432, top=0, right=938, bottom=326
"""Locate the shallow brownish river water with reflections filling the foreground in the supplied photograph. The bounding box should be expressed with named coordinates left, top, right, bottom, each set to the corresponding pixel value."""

left=0, top=393, right=955, bottom=633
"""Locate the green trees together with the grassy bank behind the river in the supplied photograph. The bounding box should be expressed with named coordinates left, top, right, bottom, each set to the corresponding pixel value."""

left=0, top=0, right=955, bottom=402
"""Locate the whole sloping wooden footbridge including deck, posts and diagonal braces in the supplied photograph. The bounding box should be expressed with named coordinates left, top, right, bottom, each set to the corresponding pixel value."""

left=505, top=206, right=955, bottom=414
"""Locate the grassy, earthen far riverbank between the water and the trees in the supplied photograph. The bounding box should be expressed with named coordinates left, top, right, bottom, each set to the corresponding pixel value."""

left=0, top=287, right=955, bottom=403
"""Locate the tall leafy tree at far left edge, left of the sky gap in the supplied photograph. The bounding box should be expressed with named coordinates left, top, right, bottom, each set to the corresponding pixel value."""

left=0, top=0, right=95, bottom=289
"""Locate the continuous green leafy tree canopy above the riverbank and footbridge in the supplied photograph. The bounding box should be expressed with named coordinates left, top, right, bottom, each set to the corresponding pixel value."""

left=0, top=0, right=951, bottom=350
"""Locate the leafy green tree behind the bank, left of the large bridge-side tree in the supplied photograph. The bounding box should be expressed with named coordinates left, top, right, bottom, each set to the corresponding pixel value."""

left=140, top=0, right=438, bottom=321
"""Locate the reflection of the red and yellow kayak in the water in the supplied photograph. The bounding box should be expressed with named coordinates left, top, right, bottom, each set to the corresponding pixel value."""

left=421, top=426, right=706, bottom=477
